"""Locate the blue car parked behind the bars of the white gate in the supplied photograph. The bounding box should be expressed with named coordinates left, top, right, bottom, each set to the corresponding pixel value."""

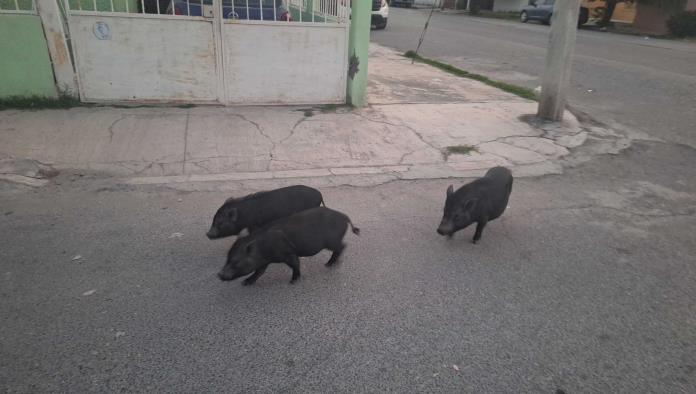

left=162, top=0, right=292, bottom=21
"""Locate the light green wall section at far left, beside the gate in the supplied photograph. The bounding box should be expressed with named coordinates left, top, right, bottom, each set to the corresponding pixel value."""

left=0, top=14, right=56, bottom=97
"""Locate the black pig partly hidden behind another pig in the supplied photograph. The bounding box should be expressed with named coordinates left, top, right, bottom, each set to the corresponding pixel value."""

left=206, top=185, right=324, bottom=239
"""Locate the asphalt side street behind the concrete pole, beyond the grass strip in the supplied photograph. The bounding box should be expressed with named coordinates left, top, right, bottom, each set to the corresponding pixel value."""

left=372, top=7, right=696, bottom=147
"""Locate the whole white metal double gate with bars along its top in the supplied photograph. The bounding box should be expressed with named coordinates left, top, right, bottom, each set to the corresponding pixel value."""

left=64, top=0, right=350, bottom=104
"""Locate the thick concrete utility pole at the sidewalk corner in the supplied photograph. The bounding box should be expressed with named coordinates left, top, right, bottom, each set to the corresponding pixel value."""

left=537, top=0, right=580, bottom=122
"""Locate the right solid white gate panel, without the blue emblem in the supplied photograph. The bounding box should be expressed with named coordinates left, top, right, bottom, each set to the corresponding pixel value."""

left=222, top=21, right=348, bottom=104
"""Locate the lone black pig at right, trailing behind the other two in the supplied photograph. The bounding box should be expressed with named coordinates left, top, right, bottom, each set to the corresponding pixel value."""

left=437, top=167, right=512, bottom=243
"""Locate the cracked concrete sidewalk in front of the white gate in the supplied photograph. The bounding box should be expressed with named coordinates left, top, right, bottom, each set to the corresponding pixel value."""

left=0, top=45, right=600, bottom=188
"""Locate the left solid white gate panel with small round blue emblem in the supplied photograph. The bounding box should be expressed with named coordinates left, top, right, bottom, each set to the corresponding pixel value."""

left=68, top=6, right=220, bottom=103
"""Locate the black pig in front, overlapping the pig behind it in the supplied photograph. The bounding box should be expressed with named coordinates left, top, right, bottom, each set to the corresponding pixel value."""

left=218, top=207, right=360, bottom=286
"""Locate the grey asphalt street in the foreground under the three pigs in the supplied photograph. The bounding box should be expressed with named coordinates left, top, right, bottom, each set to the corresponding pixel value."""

left=0, top=138, right=696, bottom=393
